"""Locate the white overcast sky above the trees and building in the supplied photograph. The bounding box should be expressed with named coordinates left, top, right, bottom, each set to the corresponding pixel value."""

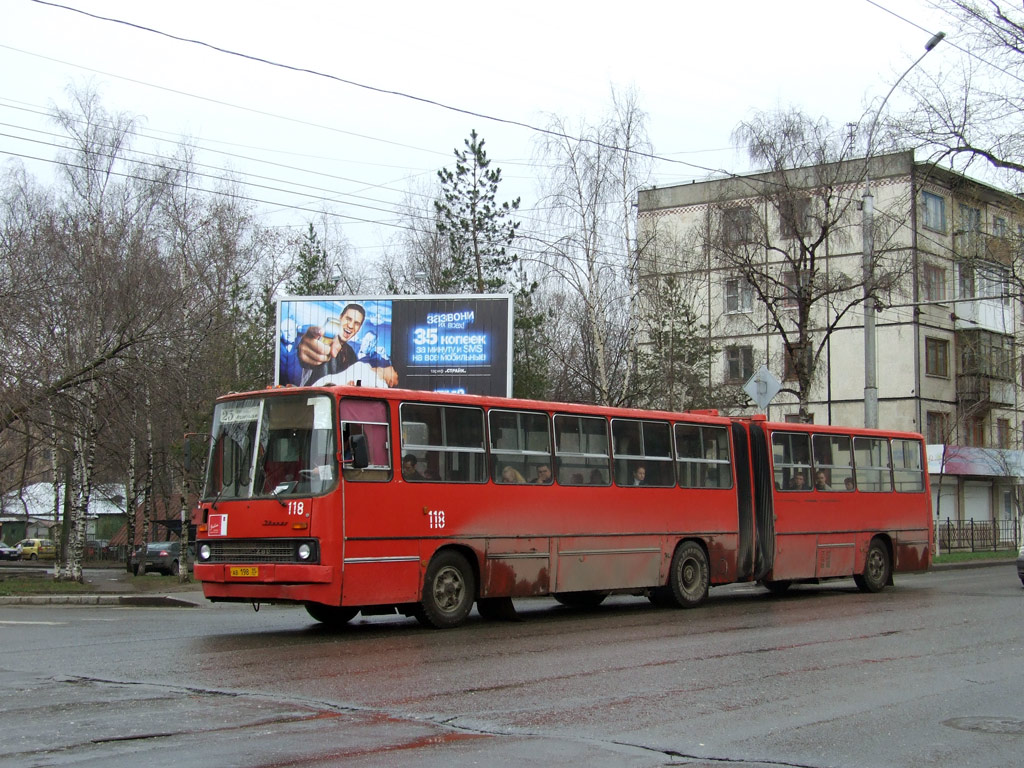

left=0, top=0, right=955, bottom=256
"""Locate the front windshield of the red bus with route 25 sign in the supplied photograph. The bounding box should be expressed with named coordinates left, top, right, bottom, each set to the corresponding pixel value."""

left=204, top=394, right=338, bottom=501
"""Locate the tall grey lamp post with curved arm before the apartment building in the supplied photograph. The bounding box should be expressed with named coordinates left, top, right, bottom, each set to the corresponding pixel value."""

left=861, top=32, right=946, bottom=429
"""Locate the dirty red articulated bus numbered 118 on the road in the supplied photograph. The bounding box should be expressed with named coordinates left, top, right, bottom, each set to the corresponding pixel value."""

left=195, top=386, right=932, bottom=628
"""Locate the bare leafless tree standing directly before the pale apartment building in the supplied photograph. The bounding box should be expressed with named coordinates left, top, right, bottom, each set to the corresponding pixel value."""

left=702, top=110, right=910, bottom=419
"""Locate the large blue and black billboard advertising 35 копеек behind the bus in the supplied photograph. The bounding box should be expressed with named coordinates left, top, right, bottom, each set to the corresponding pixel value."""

left=274, top=294, right=512, bottom=396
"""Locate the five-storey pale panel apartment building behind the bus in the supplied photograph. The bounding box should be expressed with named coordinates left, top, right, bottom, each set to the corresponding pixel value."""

left=638, top=152, right=1024, bottom=520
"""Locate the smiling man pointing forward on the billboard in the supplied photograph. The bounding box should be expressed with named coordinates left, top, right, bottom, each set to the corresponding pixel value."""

left=294, top=302, right=398, bottom=387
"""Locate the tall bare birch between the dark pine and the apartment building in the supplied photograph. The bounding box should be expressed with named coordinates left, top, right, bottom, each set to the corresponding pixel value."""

left=539, top=87, right=648, bottom=404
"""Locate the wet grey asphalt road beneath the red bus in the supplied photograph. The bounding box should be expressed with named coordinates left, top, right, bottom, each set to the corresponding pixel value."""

left=0, top=562, right=1024, bottom=768
